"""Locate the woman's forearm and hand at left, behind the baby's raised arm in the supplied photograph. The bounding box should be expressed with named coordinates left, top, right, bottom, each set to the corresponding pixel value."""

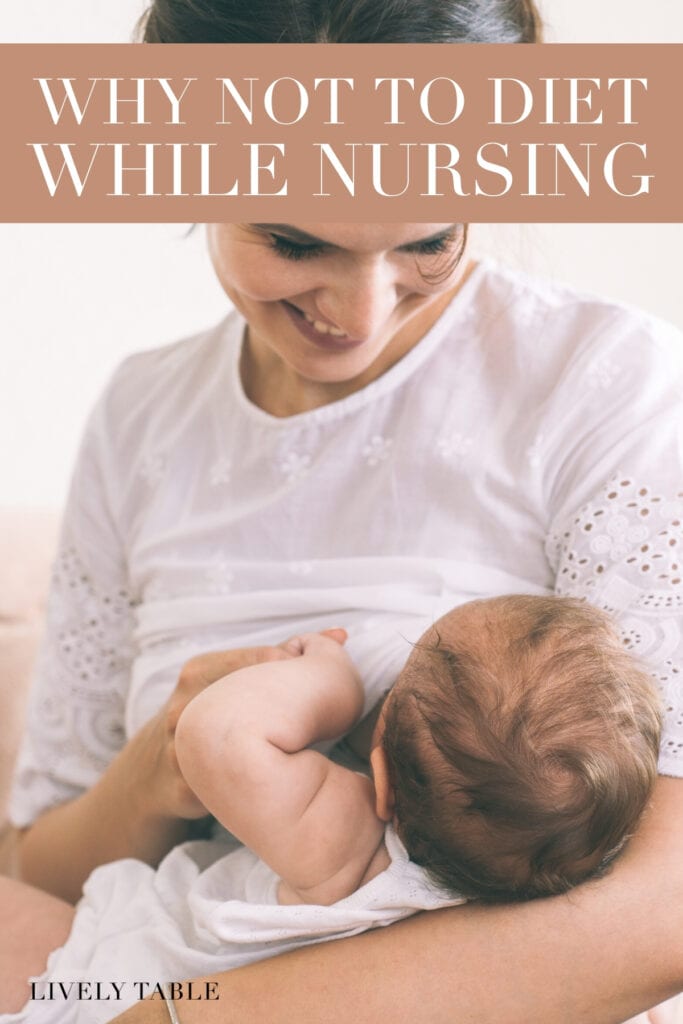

left=18, top=647, right=291, bottom=902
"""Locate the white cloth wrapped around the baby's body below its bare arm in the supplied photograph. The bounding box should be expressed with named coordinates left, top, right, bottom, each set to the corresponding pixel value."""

left=6, top=826, right=462, bottom=1024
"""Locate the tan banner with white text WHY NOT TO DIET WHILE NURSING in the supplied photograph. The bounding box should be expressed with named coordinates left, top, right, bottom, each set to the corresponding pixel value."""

left=0, top=44, right=683, bottom=222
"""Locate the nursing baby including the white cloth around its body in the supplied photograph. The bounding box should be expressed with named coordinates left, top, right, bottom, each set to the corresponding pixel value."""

left=25, top=597, right=659, bottom=1024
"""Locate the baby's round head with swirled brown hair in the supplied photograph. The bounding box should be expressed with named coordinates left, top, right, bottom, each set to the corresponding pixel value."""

left=373, top=596, right=660, bottom=902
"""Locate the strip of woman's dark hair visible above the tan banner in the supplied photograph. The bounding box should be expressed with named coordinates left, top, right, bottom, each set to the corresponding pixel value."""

left=139, top=0, right=542, bottom=43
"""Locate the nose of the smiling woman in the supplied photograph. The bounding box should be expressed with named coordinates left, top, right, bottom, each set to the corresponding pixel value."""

left=315, top=258, right=398, bottom=340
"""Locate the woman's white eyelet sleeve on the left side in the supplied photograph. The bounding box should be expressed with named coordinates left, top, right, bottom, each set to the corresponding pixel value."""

left=9, top=391, right=133, bottom=827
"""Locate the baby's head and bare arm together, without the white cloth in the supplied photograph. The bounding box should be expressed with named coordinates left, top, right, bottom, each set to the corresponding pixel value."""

left=176, top=596, right=659, bottom=904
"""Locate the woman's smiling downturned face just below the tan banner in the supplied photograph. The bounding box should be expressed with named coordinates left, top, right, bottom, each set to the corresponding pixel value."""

left=209, top=223, right=473, bottom=403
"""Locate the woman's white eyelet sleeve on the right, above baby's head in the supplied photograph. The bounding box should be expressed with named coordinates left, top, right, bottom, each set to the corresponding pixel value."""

left=547, top=311, right=683, bottom=776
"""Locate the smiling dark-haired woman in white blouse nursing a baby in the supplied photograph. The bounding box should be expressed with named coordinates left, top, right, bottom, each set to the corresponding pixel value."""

left=2, top=2, right=683, bottom=1024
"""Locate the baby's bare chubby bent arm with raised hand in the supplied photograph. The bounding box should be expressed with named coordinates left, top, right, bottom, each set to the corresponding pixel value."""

left=176, top=634, right=388, bottom=903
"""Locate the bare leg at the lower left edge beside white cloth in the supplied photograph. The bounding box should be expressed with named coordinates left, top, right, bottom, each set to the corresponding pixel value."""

left=0, top=878, right=74, bottom=1013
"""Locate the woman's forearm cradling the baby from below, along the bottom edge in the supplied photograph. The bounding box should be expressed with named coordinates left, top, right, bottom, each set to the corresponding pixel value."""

left=108, top=778, right=683, bottom=1024
